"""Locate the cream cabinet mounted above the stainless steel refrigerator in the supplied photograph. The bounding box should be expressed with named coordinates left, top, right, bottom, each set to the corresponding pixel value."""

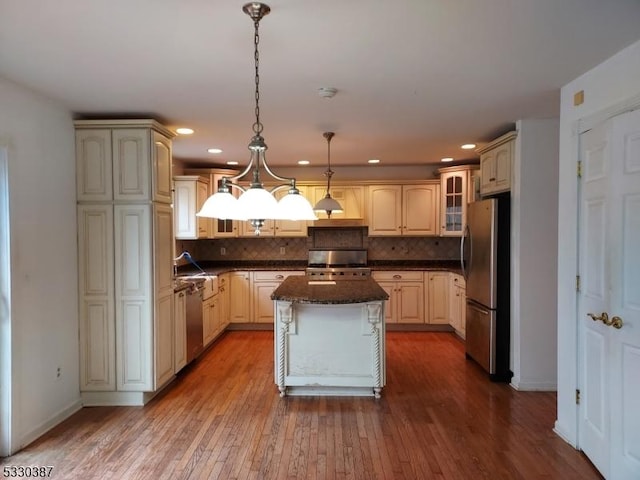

left=477, top=131, right=517, bottom=196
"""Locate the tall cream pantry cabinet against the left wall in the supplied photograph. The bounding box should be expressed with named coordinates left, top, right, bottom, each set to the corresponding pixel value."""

left=75, top=120, right=174, bottom=405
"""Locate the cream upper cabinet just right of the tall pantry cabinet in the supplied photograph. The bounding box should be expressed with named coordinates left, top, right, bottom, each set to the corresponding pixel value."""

left=173, top=175, right=211, bottom=240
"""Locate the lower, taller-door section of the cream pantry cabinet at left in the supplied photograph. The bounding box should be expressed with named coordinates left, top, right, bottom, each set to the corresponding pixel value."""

left=78, top=204, right=174, bottom=405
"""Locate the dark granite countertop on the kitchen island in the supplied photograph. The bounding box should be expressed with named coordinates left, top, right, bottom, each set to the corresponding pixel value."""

left=271, top=276, right=389, bottom=305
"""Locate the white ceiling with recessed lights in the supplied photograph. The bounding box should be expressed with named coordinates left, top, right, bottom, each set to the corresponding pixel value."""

left=0, top=0, right=640, bottom=166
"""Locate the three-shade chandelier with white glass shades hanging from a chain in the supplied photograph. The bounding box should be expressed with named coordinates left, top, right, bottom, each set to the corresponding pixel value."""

left=196, top=2, right=317, bottom=235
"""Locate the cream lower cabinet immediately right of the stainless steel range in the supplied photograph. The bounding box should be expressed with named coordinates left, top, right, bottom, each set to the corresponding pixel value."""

left=372, top=271, right=425, bottom=323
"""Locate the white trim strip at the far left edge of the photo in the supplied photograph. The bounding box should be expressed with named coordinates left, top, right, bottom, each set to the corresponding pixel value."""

left=0, top=145, right=13, bottom=457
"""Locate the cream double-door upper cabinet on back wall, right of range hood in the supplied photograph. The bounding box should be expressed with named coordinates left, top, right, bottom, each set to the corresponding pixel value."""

left=367, top=182, right=440, bottom=236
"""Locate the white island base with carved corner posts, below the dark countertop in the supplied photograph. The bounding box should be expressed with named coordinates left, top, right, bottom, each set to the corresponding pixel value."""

left=274, top=300, right=385, bottom=398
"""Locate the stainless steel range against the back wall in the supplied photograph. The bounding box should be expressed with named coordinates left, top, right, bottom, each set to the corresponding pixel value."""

left=306, top=249, right=371, bottom=280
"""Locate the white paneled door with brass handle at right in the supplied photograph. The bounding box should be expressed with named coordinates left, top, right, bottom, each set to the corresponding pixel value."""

left=578, top=107, right=640, bottom=479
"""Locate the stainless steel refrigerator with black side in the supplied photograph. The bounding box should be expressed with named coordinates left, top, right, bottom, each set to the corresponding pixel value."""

left=460, top=193, right=512, bottom=382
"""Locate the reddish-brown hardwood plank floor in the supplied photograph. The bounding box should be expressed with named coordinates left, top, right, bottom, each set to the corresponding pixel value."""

left=1, top=331, right=601, bottom=480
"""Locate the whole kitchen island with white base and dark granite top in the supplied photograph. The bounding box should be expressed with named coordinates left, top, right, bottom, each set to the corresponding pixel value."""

left=271, top=276, right=388, bottom=398
